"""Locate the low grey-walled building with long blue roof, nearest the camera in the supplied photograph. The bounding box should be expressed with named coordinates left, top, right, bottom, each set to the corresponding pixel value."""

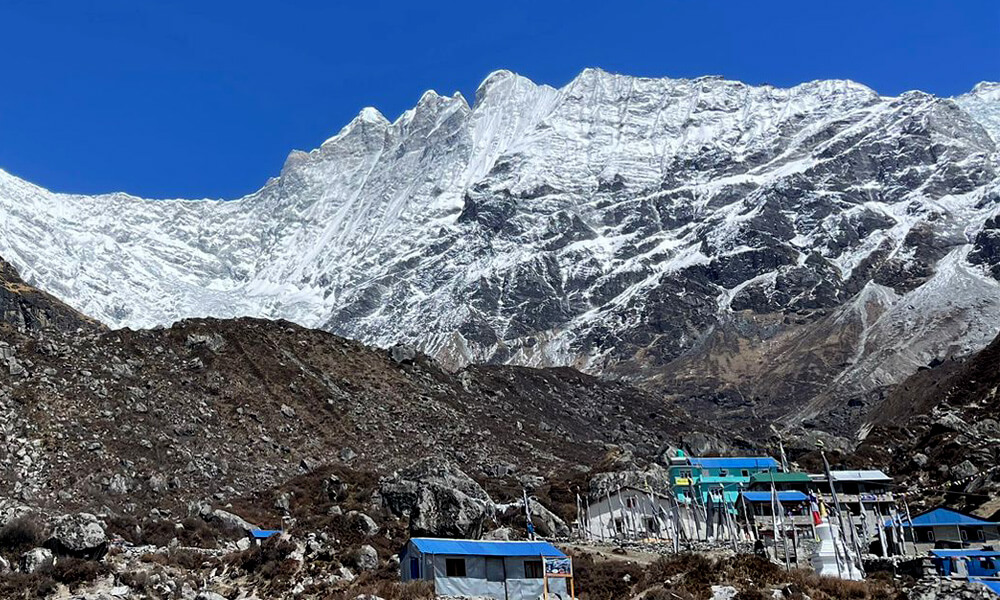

left=399, top=538, right=568, bottom=600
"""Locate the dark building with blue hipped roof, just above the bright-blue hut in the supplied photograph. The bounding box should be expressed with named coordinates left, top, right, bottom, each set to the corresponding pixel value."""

left=899, top=507, right=1000, bottom=553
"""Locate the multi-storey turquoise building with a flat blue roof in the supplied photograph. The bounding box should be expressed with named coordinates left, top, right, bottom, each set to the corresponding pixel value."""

left=669, top=452, right=781, bottom=507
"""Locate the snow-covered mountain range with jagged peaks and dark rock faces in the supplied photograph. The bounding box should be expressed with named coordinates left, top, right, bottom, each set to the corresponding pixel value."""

left=0, top=69, right=1000, bottom=426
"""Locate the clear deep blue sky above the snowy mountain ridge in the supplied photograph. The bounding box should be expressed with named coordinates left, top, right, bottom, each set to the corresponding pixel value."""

left=0, top=0, right=1000, bottom=198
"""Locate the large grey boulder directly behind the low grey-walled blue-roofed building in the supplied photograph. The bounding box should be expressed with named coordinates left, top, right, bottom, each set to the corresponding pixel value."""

left=379, top=458, right=493, bottom=539
